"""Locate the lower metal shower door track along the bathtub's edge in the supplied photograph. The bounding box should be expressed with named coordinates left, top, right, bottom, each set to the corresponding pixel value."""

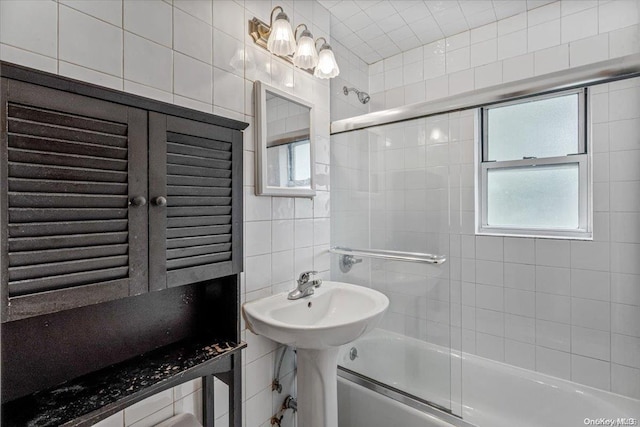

left=338, top=366, right=476, bottom=427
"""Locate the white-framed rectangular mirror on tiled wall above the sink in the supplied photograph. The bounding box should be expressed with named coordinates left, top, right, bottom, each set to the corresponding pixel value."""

left=255, top=81, right=316, bottom=197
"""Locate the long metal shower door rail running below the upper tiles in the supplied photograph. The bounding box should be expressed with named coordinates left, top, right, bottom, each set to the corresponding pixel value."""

left=330, top=53, right=640, bottom=135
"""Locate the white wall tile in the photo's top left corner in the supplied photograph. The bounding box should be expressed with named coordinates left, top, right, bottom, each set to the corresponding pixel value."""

left=0, top=0, right=57, bottom=58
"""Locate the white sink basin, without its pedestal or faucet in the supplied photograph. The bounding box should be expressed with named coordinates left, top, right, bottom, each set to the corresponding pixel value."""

left=242, top=282, right=389, bottom=350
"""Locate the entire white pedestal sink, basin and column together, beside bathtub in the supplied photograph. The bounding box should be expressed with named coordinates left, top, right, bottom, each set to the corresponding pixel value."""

left=242, top=282, right=389, bottom=427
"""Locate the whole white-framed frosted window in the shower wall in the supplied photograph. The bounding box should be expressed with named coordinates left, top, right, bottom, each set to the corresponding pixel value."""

left=477, top=89, right=591, bottom=239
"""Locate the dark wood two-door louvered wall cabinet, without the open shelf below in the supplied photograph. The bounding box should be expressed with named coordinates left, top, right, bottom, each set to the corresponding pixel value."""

left=0, top=64, right=246, bottom=321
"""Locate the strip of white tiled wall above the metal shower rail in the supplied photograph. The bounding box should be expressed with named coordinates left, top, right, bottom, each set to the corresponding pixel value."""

left=368, top=0, right=640, bottom=111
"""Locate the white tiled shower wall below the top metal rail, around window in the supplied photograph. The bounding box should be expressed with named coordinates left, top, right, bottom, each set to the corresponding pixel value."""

left=332, top=74, right=640, bottom=398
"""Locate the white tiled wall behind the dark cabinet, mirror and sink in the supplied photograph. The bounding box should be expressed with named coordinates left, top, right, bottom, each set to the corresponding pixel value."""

left=0, top=0, right=330, bottom=427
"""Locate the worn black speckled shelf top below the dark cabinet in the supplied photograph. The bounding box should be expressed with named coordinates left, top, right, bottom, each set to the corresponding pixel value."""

left=2, top=340, right=246, bottom=427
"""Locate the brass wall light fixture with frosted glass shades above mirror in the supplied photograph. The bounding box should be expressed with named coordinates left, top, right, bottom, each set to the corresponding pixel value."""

left=249, top=6, right=340, bottom=79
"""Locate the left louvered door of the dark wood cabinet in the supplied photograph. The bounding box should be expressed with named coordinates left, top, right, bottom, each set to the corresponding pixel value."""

left=0, top=79, right=148, bottom=320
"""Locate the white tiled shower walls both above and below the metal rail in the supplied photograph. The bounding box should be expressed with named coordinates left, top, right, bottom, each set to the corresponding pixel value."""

left=332, top=0, right=640, bottom=404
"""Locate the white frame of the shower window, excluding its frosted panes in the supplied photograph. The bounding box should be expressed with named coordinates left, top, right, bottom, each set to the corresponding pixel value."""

left=476, top=88, right=593, bottom=240
